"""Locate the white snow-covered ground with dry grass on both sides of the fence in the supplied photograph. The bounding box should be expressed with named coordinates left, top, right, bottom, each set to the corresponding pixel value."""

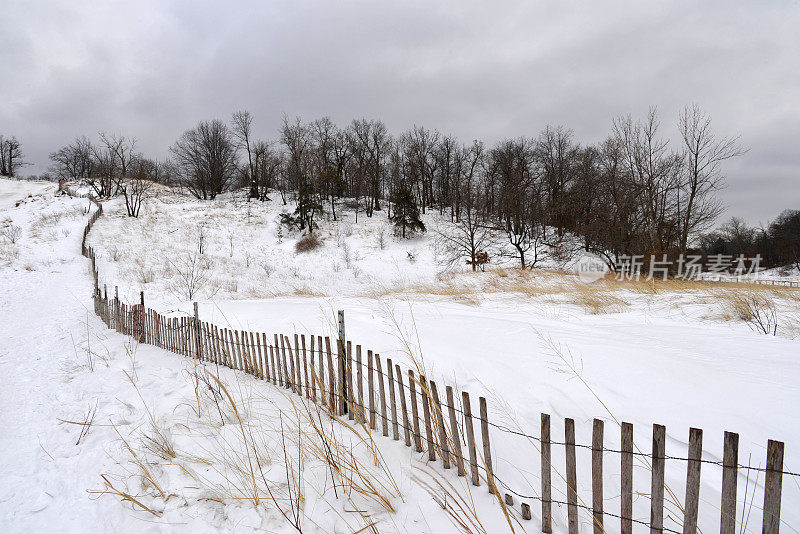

left=0, top=182, right=800, bottom=532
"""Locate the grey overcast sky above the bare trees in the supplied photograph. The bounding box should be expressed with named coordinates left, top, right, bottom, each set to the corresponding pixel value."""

left=0, top=0, right=800, bottom=223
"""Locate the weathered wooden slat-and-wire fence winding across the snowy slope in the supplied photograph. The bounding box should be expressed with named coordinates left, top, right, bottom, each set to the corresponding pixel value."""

left=67, top=190, right=800, bottom=534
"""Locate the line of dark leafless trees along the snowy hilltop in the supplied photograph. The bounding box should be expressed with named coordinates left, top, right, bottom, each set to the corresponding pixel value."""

left=25, top=106, right=796, bottom=267
